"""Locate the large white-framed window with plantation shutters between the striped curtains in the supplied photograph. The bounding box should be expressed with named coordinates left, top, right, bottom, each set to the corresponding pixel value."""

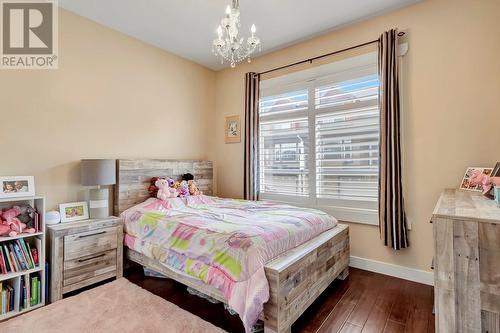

left=259, top=53, right=379, bottom=223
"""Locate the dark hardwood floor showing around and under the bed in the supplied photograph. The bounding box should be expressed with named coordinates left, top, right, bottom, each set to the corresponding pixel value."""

left=125, top=266, right=434, bottom=333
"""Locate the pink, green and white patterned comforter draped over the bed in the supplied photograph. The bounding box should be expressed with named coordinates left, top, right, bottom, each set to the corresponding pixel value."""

left=122, top=195, right=337, bottom=332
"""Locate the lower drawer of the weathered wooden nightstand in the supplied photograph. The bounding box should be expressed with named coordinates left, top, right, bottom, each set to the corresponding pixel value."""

left=63, top=250, right=116, bottom=287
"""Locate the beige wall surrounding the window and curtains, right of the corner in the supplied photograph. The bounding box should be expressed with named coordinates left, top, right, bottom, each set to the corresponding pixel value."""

left=215, top=0, right=500, bottom=270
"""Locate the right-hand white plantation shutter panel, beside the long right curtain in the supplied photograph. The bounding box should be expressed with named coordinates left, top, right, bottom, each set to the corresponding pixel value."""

left=315, top=73, right=379, bottom=205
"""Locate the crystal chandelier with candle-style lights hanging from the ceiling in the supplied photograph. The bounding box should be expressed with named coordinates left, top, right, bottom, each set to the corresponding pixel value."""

left=212, top=0, right=260, bottom=68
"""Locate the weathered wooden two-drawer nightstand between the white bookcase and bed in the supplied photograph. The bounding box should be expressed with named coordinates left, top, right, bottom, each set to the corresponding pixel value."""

left=47, top=216, right=123, bottom=302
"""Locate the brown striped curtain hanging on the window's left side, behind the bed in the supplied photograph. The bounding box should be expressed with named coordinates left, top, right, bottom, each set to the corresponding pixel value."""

left=243, top=73, right=260, bottom=200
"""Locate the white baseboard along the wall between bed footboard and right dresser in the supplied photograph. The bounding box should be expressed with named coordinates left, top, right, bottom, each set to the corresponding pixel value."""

left=349, top=256, right=434, bottom=286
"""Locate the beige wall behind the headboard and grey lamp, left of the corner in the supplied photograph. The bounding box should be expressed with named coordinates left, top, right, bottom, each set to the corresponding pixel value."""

left=0, top=10, right=215, bottom=208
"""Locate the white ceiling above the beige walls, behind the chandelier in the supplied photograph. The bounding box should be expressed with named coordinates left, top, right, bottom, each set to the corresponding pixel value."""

left=59, top=0, right=419, bottom=69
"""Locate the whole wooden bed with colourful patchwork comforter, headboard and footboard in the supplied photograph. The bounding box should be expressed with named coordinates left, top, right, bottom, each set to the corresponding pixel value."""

left=115, top=160, right=349, bottom=332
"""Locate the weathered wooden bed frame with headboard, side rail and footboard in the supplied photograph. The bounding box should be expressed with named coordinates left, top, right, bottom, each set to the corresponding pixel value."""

left=114, top=160, right=349, bottom=333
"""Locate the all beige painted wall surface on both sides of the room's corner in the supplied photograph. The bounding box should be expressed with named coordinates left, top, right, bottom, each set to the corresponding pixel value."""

left=0, top=0, right=500, bottom=270
